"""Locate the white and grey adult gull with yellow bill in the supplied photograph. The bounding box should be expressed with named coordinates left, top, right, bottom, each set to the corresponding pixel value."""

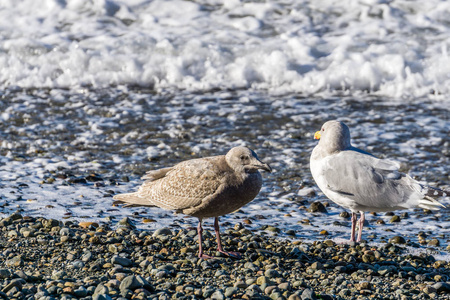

left=310, top=121, right=446, bottom=242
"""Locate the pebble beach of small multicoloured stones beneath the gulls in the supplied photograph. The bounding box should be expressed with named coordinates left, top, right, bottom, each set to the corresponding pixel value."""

left=0, top=212, right=450, bottom=300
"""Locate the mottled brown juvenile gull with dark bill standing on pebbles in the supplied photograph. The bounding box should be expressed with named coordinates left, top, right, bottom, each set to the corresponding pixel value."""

left=114, top=147, right=272, bottom=258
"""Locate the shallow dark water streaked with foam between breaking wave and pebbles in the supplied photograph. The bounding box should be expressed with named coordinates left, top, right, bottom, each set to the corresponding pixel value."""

left=0, top=88, right=450, bottom=253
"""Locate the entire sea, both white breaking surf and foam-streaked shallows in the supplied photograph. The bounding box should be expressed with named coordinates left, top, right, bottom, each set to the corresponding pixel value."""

left=0, top=0, right=450, bottom=249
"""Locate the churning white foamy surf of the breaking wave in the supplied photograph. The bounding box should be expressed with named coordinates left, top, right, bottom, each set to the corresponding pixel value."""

left=0, top=0, right=450, bottom=99
